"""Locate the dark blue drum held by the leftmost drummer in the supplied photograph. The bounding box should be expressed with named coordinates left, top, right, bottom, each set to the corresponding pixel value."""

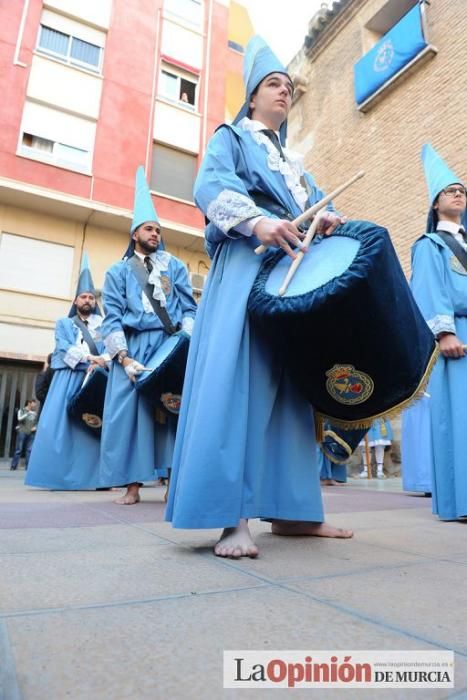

left=67, top=367, right=108, bottom=437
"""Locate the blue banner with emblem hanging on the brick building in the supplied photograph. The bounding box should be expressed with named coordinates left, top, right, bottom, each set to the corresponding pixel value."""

left=354, top=3, right=427, bottom=104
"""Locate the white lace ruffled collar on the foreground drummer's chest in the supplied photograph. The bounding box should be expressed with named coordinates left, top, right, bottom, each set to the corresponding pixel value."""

left=238, top=117, right=308, bottom=211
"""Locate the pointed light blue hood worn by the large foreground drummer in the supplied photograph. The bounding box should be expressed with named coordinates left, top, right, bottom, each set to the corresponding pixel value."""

left=233, top=35, right=288, bottom=146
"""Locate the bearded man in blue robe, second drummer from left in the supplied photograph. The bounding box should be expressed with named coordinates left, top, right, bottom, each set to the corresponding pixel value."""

left=100, top=167, right=196, bottom=505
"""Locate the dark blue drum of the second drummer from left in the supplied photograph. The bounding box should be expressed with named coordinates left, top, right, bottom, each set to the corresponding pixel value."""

left=135, top=331, right=190, bottom=415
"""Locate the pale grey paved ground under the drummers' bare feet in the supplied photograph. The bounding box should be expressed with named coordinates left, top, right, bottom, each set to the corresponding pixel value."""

left=0, top=463, right=467, bottom=700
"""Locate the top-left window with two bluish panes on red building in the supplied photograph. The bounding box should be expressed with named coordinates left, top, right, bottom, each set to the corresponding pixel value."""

left=37, top=24, right=102, bottom=71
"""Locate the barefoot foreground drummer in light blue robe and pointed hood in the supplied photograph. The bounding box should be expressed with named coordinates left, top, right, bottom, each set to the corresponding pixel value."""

left=167, top=37, right=352, bottom=558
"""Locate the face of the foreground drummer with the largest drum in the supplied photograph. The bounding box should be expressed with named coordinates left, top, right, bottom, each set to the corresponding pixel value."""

left=250, top=73, right=293, bottom=131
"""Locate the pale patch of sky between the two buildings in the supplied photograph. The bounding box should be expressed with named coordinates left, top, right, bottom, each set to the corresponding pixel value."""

left=240, top=0, right=332, bottom=64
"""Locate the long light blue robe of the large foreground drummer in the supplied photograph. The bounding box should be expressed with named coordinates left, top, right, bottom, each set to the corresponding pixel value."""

left=166, top=127, right=334, bottom=528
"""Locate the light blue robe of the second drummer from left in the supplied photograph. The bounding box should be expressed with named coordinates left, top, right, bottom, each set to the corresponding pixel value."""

left=99, top=254, right=196, bottom=486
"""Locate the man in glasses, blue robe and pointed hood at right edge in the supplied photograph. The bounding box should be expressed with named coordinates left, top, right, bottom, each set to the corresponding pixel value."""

left=410, top=144, right=467, bottom=520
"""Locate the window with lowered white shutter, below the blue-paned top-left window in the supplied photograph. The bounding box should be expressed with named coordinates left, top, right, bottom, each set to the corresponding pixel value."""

left=19, top=102, right=96, bottom=173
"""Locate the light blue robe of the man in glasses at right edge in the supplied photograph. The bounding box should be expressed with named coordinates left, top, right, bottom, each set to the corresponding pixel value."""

left=411, top=233, right=467, bottom=520
